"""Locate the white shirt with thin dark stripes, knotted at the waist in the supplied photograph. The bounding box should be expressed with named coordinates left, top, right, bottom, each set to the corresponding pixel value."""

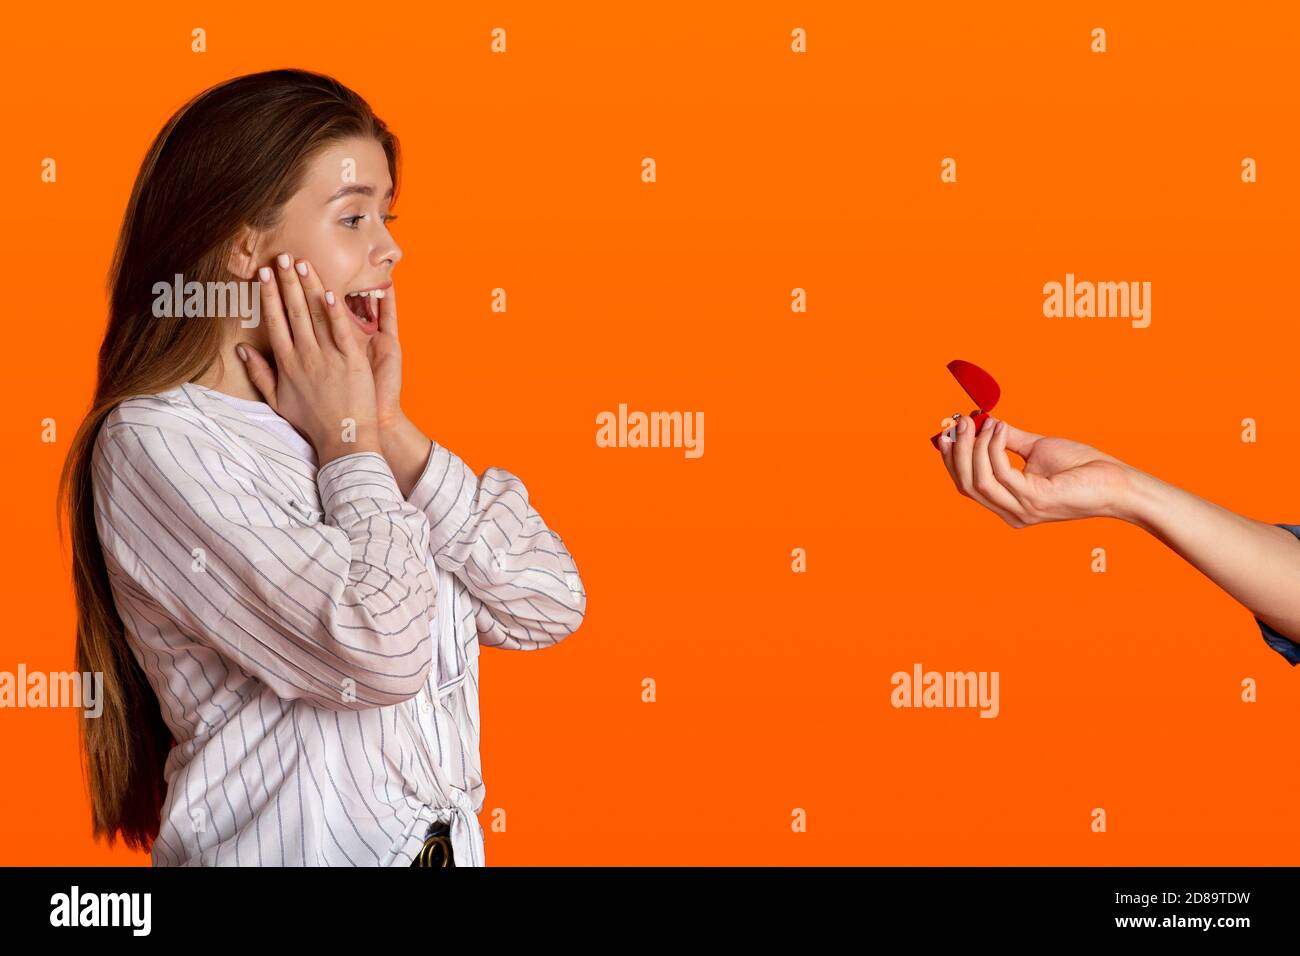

left=94, top=382, right=586, bottom=866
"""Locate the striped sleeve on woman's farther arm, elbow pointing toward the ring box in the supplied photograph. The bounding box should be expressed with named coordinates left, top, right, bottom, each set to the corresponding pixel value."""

left=410, top=441, right=586, bottom=650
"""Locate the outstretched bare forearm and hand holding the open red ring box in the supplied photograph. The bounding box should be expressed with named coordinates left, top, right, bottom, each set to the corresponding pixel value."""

left=939, top=416, right=1300, bottom=666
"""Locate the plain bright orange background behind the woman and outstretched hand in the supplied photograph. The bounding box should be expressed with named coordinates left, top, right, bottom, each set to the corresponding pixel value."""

left=0, top=3, right=1300, bottom=865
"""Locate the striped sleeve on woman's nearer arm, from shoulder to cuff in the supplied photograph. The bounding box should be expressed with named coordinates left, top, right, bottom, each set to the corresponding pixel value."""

left=94, top=406, right=437, bottom=710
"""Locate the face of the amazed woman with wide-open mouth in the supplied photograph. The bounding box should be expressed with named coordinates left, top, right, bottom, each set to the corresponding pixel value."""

left=248, top=137, right=402, bottom=347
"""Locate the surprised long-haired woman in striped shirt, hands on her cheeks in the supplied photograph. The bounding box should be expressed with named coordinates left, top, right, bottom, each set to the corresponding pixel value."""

left=60, top=70, right=586, bottom=866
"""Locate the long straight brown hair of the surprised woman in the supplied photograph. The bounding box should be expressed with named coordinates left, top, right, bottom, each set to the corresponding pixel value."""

left=57, top=69, right=398, bottom=849
